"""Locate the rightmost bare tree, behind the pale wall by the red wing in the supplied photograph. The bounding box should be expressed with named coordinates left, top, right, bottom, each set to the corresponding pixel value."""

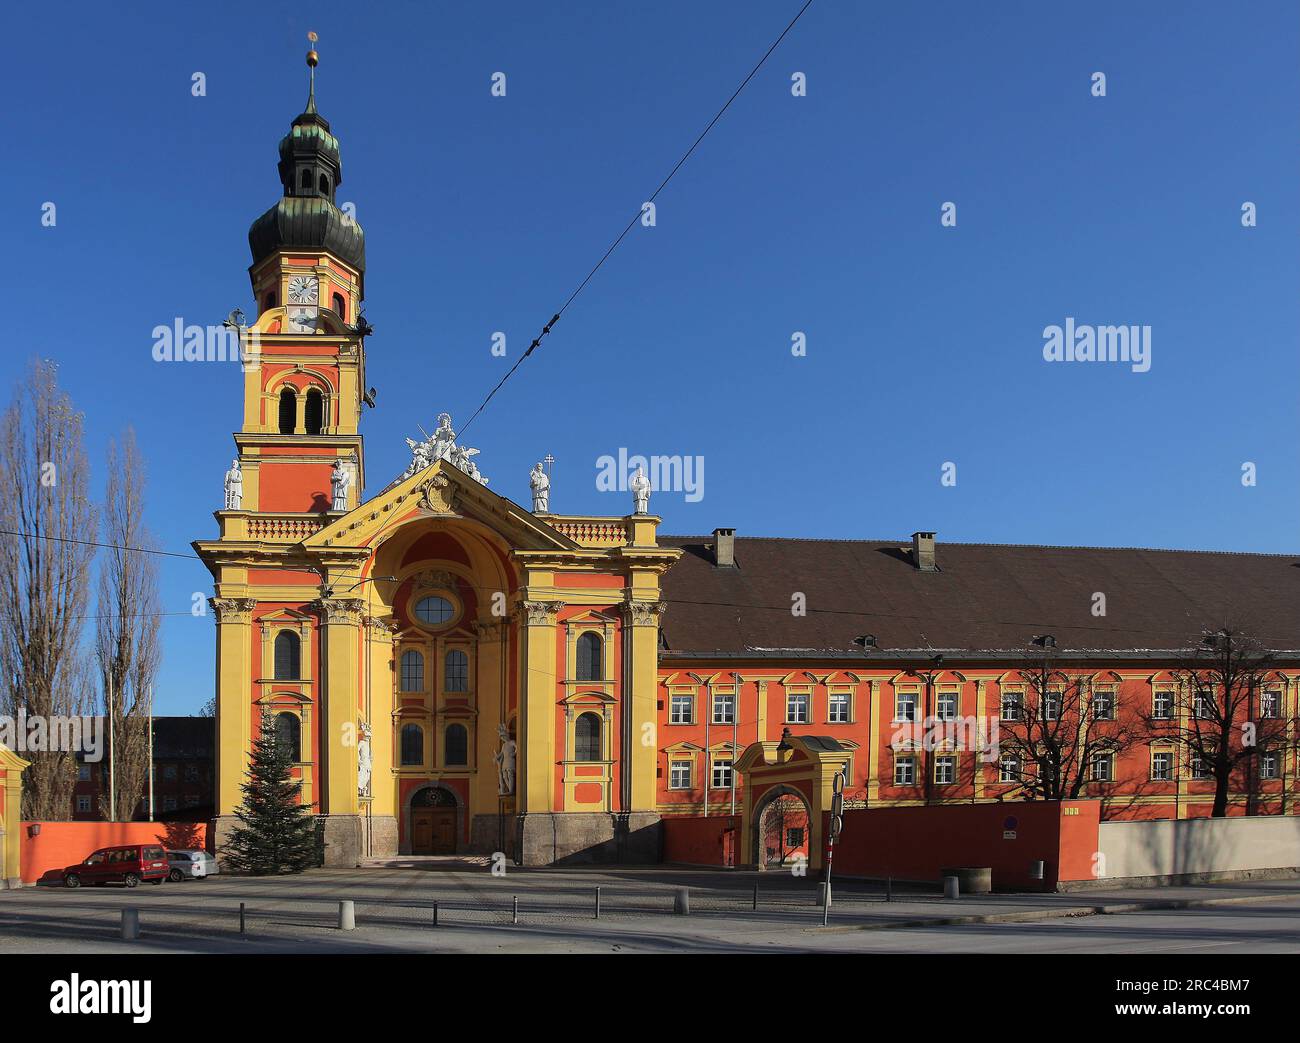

left=1143, top=627, right=1287, bottom=818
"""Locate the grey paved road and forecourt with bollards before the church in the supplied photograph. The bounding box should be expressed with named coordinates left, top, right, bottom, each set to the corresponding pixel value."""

left=0, top=866, right=1300, bottom=953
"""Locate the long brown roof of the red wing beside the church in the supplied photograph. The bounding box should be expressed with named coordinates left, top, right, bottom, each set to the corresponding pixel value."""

left=659, top=536, right=1300, bottom=661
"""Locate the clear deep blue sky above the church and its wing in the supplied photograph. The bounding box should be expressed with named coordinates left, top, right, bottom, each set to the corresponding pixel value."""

left=0, top=0, right=1300, bottom=713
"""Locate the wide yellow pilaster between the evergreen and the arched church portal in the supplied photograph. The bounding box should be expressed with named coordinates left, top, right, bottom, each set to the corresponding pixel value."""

left=315, top=597, right=364, bottom=866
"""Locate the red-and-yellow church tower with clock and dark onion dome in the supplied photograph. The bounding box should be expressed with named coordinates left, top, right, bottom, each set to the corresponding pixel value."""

left=235, top=36, right=369, bottom=514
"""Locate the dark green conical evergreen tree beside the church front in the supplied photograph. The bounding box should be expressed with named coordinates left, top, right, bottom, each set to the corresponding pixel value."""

left=225, top=711, right=320, bottom=877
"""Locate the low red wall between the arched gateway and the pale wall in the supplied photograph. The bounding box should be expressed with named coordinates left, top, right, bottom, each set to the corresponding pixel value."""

left=833, top=800, right=1101, bottom=888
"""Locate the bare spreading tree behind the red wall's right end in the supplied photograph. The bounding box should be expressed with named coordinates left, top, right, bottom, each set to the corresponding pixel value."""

left=998, top=644, right=1136, bottom=800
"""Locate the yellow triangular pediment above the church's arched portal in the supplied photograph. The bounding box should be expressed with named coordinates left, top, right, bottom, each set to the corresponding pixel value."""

left=302, top=460, right=579, bottom=551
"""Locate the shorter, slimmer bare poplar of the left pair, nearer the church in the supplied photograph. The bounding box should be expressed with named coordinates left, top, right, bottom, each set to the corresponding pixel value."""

left=95, top=428, right=160, bottom=822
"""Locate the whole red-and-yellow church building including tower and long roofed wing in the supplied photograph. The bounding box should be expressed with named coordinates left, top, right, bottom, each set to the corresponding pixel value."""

left=194, top=56, right=1300, bottom=865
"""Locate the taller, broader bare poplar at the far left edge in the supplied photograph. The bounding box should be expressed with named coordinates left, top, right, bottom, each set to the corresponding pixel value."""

left=0, top=360, right=95, bottom=821
